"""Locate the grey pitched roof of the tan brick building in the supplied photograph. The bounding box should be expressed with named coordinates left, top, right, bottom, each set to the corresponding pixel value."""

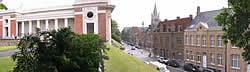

left=186, top=10, right=221, bottom=30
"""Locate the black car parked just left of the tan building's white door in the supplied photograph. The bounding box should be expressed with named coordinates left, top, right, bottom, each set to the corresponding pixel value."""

left=184, top=64, right=201, bottom=72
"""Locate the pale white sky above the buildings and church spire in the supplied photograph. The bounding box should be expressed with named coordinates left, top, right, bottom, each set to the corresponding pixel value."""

left=2, top=0, right=227, bottom=30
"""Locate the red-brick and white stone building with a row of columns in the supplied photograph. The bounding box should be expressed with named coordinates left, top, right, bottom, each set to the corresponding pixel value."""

left=0, top=0, right=114, bottom=42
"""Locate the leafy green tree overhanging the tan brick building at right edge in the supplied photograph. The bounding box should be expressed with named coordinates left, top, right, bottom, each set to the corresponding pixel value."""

left=215, top=0, right=250, bottom=61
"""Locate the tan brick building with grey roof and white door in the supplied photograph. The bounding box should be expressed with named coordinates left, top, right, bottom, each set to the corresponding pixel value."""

left=184, top=7, right=249, bottom=72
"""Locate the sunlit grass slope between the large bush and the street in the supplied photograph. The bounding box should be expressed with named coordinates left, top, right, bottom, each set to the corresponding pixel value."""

left=105, top=45, right=158, bottom=72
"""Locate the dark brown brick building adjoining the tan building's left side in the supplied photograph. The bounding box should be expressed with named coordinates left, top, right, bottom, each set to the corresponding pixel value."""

left=152, top=15, right=192, bottom=61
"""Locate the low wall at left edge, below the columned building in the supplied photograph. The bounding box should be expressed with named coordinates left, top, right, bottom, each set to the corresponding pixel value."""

left=0, top=39, right=19, bottom=46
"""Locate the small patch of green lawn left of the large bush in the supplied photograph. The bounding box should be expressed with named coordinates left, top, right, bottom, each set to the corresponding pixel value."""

left=0, top=56, right=15, bottom=72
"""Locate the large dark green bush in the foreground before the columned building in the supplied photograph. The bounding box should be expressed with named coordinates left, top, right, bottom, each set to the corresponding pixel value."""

left=12, top=28, right=107, bottom=72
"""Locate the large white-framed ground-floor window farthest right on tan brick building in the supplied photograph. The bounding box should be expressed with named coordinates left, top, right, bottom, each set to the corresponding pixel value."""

left=232, top=54, right=240, bottom=68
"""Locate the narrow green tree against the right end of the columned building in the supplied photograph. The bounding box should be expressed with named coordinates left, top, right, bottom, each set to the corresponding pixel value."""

left=111, top=20, right=121, bottom=42
